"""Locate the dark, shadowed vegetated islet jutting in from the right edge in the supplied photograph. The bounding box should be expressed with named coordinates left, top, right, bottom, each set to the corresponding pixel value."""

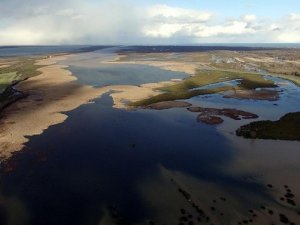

left=236, top=112, right=300, bottom=141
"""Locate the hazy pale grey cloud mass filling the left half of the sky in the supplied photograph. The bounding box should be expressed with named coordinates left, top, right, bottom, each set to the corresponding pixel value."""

left=0, top=0, right=144, bottom=45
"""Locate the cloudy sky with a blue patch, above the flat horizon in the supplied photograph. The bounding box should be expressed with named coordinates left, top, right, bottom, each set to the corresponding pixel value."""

left=0, top=0, right=300, bottom=45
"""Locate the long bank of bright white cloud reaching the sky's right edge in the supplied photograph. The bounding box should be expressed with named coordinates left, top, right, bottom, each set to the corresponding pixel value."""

left=142, top=5, right=300, bottom=43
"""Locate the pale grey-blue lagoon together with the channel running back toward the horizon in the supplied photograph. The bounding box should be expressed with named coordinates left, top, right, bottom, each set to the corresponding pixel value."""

left=62, top=47, right=188, bottom=87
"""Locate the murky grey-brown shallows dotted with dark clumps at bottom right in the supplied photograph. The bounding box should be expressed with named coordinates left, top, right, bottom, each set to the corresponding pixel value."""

left=140, top=137, right=300, bottom=225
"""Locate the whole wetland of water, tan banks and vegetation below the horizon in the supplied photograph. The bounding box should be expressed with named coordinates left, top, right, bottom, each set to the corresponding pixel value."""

left=0, top=46, right=300, bottom=225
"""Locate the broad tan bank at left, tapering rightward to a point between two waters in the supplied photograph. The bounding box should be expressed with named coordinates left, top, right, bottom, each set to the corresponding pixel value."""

left=0, top=56, right=112, bottom=159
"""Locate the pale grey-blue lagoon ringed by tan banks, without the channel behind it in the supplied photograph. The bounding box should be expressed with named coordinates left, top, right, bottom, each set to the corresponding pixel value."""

left=69, top=64, right=187, bottom=87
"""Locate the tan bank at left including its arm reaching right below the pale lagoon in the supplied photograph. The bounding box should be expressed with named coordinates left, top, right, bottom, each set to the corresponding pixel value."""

left=0, top=54, right=183, bottom=161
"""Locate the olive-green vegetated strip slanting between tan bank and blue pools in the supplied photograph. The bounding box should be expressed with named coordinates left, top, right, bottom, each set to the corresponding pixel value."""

left=130, top=70, right=276, bottom=107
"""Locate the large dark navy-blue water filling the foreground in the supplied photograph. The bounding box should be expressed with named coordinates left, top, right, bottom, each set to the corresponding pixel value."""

left=0, top=95, right=268, bottom=225
